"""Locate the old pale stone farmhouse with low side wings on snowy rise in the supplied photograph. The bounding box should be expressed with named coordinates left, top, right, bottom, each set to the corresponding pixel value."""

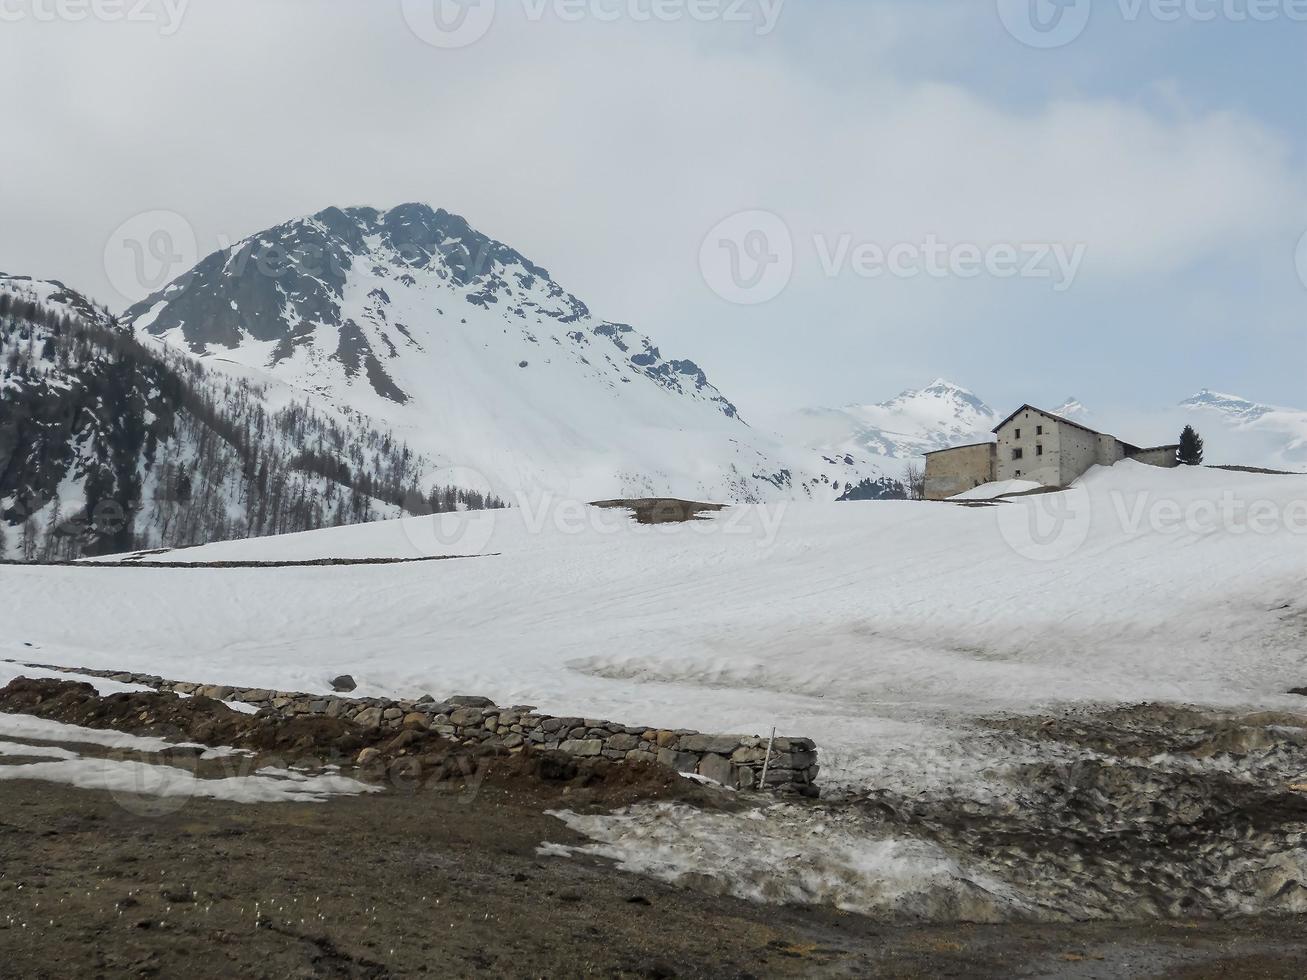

left=925, top=405, right=1180, bottom=500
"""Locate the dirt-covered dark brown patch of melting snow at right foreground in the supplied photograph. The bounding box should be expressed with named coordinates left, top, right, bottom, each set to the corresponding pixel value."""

left=853, top=704, right=1307, bottom=919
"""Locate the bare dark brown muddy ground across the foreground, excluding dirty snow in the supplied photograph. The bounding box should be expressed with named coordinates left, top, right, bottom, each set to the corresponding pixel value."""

left=0, top=682, right=1307, bottom=979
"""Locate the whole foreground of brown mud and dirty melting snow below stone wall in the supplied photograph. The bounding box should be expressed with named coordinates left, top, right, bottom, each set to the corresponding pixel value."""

left=0, top=679, right=1307, bottom=977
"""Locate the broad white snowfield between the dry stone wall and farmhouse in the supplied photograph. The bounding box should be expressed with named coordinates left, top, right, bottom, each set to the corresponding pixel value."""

left=0, top=463, right=1307, bottom=791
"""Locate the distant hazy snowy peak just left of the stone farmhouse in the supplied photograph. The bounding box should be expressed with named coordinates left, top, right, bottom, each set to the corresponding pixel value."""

left=771, top=378, right=999, bottom=474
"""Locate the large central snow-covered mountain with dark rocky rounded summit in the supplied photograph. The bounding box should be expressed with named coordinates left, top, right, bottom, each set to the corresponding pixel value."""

left=125, top=204, right=876, bottom=502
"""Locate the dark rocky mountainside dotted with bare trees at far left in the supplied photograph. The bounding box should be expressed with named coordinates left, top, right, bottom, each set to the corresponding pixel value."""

left=0, top=276, right=494, bottom=561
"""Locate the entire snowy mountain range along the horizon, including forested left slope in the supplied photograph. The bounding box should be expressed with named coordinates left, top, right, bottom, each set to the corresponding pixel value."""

left=0, top=204, right=1307, bottom=558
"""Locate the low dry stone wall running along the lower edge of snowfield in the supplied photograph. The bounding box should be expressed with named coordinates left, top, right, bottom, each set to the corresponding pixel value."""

left=15, top=664, right=819, bottom=796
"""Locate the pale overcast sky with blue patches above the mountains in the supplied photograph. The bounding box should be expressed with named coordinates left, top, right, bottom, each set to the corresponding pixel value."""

left=0, top=0, right=1307, bottom=417
